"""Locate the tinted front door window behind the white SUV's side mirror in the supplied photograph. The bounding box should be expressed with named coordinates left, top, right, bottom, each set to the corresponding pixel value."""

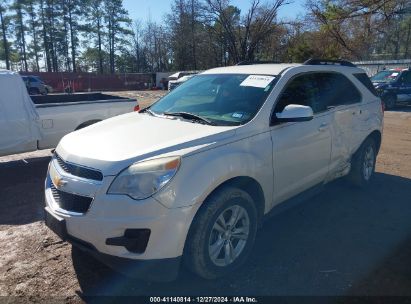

left=274, top=74, right=325, bottom=113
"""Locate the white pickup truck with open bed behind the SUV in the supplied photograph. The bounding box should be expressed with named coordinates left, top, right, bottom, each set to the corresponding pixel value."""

left=0, top=70, right=138, bottom=156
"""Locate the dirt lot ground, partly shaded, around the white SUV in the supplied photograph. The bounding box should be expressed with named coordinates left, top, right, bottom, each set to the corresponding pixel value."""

left=0, top=92, right=411, bottom=302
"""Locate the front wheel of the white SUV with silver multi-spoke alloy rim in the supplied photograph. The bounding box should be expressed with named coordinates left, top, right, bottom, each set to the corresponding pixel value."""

left=184, top=186, right=258, bottom=279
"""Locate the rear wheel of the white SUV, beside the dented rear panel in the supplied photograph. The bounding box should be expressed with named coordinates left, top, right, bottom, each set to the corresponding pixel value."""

left=348, top=137, right=377, bottom=188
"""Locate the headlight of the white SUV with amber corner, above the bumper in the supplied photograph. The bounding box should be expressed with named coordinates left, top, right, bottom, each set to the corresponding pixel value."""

left=107, top=156, right=181, bottom=200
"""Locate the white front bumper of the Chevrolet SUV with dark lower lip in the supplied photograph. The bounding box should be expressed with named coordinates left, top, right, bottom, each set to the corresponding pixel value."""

left=45, top=159, right=196, bottom=280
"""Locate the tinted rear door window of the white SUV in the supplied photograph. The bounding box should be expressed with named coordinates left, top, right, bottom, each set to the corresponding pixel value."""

left=318, top=73, right=361, bottom=108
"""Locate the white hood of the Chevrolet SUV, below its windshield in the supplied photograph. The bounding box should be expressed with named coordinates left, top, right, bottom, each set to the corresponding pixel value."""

left=56, top=112, right=236, bottom=175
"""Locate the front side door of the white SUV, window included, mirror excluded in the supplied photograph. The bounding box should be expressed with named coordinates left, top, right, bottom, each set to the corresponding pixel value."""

left=271, top=73, right=331, bottom=203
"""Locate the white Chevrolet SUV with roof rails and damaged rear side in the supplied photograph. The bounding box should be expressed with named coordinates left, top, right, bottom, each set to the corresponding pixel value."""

left=45, top=60, right=383, bottom=280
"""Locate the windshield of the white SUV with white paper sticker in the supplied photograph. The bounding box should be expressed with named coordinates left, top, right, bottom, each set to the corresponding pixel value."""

left=150, top=74, right=275, bottom=125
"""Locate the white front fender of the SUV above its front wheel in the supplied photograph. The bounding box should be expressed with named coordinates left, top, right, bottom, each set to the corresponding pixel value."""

left=155, top=132, right=273, bottom=209
